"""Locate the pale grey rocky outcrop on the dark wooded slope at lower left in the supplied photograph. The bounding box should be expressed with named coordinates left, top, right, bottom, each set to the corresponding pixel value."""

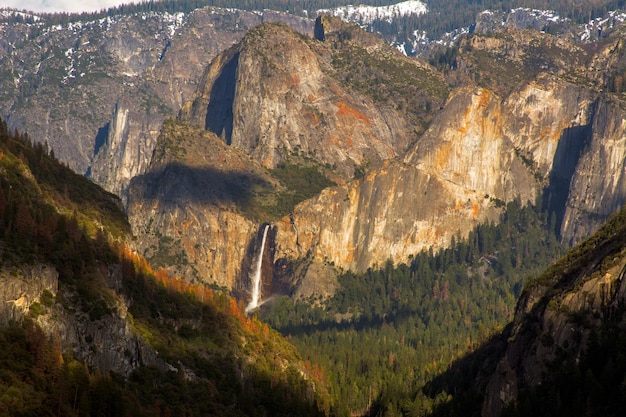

left=0, top=264, right=156, bottom=375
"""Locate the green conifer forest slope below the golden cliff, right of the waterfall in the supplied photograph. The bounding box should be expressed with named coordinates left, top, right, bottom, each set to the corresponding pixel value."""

left=263, top=198, right=563, bottom=415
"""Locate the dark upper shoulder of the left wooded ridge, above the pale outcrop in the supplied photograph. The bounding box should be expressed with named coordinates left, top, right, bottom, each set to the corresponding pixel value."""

left=0, top=120, right=130, bottom=260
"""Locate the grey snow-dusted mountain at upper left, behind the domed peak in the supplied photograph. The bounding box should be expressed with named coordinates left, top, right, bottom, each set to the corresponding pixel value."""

left=0, top=8, right=313, bottom=200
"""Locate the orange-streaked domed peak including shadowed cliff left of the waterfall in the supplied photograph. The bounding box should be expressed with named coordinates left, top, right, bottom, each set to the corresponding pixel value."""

left=128, top=18, right=448, bottom=288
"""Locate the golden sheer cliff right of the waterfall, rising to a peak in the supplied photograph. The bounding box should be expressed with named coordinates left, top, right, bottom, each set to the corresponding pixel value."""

left=277, top=89, right=537, bottom=271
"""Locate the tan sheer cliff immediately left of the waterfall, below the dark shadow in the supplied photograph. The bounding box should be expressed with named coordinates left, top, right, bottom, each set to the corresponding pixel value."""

left=129, top=189, right=258, bottom=289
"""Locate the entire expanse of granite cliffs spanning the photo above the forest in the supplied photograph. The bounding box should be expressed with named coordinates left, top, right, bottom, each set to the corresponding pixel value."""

left=3, top=8, right=625, bottom=302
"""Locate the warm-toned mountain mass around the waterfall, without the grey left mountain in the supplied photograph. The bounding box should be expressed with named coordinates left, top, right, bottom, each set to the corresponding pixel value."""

left=122, top=9, right=625, bottom=302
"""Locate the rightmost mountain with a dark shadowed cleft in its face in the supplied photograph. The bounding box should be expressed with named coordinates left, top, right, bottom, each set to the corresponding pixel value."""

left=449, top=24, right=625, bottom=243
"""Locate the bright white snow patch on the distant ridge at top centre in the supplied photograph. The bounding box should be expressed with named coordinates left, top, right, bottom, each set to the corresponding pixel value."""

left=317, top=0, right=428, bottom=25
